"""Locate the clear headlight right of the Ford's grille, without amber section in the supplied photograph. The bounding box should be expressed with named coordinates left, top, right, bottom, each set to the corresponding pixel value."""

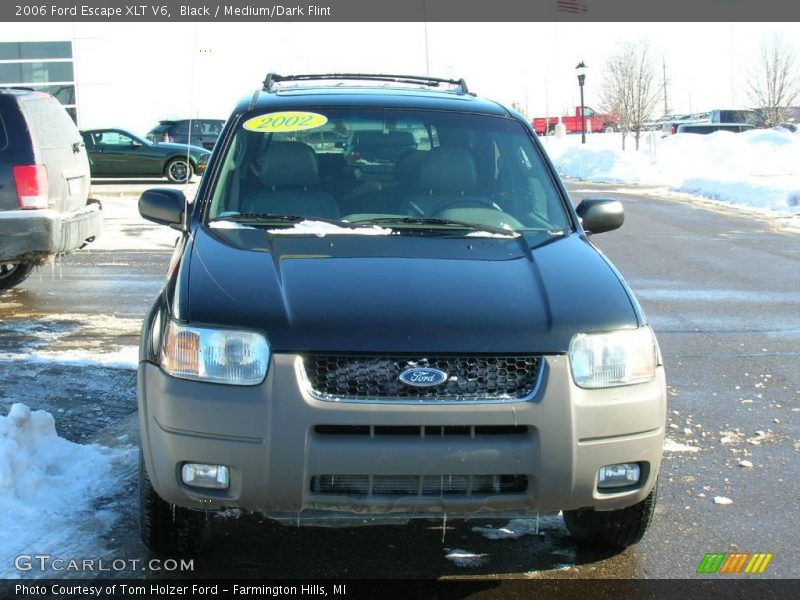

left=569, top=327, right=658, bottom=388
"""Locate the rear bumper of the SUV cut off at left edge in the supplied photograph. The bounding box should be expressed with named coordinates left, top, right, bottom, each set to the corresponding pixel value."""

left=0, top=203, right=103, bottom=262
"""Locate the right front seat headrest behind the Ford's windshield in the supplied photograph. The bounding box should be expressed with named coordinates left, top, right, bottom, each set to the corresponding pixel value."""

left=419, top=146, right=478, bottom=194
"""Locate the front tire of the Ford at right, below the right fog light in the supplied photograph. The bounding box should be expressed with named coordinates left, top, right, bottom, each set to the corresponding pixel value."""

left=564, top=487, right=656, bottom=549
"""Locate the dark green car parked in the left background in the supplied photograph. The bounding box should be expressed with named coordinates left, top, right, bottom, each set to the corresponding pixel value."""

left=81, top=129, right=211, bottom=183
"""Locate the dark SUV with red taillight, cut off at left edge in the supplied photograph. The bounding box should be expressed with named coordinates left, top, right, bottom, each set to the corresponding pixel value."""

left=0, top=88, right=102, bottom=291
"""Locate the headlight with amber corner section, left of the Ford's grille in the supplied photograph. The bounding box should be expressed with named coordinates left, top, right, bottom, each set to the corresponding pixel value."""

left=161, top=321, right=269, bottom=385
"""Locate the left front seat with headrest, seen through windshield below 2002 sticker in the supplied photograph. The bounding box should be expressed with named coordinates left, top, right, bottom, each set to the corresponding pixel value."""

left=241, top=142, right=339, bottom=219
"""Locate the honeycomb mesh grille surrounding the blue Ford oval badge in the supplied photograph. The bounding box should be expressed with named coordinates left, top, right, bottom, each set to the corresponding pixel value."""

left=303, top=354, right=541, bottom=402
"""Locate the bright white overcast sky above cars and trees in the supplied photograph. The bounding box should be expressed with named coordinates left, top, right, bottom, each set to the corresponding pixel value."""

left=0, top=23, right=800, bottom=133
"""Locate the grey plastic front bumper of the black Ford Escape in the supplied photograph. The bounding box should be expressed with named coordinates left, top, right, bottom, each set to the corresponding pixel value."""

left=138, top=354, right=666, bottom=516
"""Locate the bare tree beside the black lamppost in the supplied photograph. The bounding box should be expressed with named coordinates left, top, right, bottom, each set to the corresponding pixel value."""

left=600, top=41, right=660, bottom=150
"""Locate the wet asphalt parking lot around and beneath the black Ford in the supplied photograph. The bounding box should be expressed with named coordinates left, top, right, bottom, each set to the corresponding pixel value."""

left=0, top=182, right=800, bottom=579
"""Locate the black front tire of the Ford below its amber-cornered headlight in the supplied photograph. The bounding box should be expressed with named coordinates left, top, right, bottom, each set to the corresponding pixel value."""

left=139, top=449, right=206, bottom=555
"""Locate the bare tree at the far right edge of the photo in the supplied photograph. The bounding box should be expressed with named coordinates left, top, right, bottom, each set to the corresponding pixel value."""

left=748, top=33, right=800, bottom=127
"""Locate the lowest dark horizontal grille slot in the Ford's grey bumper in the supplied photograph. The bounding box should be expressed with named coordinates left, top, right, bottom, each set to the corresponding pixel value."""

left=311, top=475, right=528, bottom=497
